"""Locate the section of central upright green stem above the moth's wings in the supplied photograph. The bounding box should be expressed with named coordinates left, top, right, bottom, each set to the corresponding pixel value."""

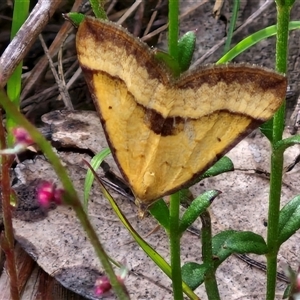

left=168, top=0, right=179, bottom=62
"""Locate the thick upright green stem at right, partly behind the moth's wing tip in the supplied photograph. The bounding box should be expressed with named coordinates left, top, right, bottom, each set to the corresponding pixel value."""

left=266, top=1, right=291, bottom=300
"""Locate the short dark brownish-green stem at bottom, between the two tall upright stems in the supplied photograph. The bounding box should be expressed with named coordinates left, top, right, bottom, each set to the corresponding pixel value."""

left=200, top=211, right=220, bottom=300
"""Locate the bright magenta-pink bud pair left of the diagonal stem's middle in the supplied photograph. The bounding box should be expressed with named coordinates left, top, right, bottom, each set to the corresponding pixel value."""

left=37, top=181, right=64, bottom=208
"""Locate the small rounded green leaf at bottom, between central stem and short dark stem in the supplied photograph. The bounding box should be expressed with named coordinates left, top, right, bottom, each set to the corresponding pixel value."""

left=181, top=262, right=207, bottom=290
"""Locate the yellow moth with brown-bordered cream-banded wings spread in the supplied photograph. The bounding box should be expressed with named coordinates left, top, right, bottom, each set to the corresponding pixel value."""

left=76, top=17, right=287, bottom=211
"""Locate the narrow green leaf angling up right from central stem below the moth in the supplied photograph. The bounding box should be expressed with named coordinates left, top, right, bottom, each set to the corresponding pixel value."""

left=179, top=190, right=220, bottom=234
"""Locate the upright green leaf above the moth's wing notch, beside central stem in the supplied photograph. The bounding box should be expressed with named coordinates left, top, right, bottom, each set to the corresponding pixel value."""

left=178, top=31, right=196, bottom=72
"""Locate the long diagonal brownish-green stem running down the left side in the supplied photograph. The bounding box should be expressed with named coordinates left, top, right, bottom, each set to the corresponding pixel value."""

left=0, top=89, right=128, bottom=299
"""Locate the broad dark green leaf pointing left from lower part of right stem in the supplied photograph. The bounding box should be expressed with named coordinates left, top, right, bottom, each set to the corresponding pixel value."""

left=223, top=231, right=268, bottom=255
